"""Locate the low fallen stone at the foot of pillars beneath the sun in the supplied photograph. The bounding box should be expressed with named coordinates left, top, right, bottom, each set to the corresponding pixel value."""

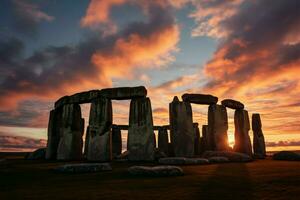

left=202, top=151, right=252, bottom=162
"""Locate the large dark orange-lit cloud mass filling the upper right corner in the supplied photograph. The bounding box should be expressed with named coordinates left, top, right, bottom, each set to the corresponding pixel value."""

left=206, top=0, right=300, bottom=89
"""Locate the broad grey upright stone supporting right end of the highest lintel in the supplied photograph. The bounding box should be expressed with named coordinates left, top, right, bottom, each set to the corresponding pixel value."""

left=127, top=98, right=155, bottom=161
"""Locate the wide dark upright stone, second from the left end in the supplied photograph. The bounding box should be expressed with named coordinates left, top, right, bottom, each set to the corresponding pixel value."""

left=57, top=104, right=84, bottom=160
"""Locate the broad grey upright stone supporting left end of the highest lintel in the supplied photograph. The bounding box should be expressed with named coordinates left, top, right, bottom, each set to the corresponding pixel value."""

left=87, top=98, right=112, bottom=162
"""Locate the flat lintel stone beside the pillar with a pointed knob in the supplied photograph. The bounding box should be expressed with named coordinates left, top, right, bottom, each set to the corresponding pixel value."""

left=181, top=94, right=218, bottom=105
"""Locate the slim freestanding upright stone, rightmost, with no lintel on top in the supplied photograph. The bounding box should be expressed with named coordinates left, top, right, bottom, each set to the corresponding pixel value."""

left=252, top=113, right=266, bottom=158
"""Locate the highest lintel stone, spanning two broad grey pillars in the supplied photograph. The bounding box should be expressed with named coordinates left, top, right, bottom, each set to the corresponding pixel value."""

left=100, top=86, right=147, bottom=100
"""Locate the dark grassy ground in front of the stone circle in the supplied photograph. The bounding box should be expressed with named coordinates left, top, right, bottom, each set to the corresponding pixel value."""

left=0, top=154, right=300, bottom=200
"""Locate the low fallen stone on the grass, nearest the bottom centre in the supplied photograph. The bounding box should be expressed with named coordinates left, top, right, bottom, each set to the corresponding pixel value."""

left=128, top=166, right=183, bottom=177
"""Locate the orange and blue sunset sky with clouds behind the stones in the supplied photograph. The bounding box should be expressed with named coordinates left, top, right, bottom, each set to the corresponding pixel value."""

left=0, top=0, right=300, bottom=151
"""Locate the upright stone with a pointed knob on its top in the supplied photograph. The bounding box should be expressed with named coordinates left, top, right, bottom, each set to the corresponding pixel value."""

left=169, top=96, right=195, bottom=157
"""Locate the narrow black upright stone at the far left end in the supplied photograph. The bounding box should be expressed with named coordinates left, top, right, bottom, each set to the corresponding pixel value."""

left=46, top=109, right=62, bottom=160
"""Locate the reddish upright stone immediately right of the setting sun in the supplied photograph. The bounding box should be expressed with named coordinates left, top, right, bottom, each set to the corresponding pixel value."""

left=233, top=109, right=252, bottom=157
